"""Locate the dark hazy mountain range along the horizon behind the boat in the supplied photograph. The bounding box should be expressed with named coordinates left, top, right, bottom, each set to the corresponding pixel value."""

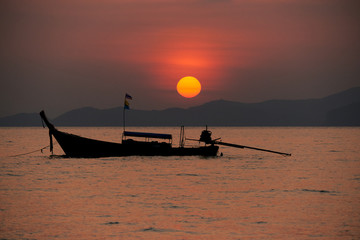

left=0, top=87, right=360, bottom=126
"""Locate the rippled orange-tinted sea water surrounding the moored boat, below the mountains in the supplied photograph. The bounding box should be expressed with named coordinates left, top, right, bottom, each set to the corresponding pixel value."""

left=0, top=128, right=360, bottom=239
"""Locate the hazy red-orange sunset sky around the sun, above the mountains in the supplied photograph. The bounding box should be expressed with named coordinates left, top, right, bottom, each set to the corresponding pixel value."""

left=0, top=0, right=360, bottom=117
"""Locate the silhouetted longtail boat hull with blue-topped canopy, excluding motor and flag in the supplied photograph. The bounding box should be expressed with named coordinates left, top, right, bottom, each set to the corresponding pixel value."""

left=40, top=111, right=219, bottom=158
